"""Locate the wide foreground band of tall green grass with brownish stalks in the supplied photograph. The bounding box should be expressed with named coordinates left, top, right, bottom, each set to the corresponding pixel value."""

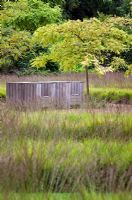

left=0, top=139, right=132, bottom=193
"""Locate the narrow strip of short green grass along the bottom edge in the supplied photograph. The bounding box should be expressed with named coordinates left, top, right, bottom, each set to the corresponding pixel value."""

left=0, top=192, right=132, bottom=200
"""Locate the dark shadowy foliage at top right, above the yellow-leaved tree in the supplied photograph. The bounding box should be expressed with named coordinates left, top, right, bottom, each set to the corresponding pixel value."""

left=43, top=0, right=131, bottom=19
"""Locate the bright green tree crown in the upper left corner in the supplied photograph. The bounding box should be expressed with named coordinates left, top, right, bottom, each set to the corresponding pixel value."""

left=0, top=0, right=61, bottom=31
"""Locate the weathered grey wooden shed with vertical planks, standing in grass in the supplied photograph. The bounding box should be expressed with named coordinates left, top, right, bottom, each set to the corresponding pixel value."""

left=6, top=81, right=84, bottom=108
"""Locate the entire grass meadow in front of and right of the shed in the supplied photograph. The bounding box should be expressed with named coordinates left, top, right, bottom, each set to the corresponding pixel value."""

left=0, top=72, right=132, bottom=200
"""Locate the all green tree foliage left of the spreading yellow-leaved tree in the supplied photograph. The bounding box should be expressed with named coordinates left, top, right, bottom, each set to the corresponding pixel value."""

left=0, top=0, right=61, bottom=74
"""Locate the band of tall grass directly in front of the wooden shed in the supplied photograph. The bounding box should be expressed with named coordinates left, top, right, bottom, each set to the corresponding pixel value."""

left=1, top=108, right=132, bottom=141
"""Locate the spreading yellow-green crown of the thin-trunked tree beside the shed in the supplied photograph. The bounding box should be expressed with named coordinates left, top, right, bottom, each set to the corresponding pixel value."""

left=32, top=18, right=132, bottom=73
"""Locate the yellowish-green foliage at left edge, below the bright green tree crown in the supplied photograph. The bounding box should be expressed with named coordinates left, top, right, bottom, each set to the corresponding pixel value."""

left=0, top=28, right=31, bottom=72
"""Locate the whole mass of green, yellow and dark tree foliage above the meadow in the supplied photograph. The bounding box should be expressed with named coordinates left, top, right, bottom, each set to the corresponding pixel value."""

left=0, top=0, right=132, bottom=72
